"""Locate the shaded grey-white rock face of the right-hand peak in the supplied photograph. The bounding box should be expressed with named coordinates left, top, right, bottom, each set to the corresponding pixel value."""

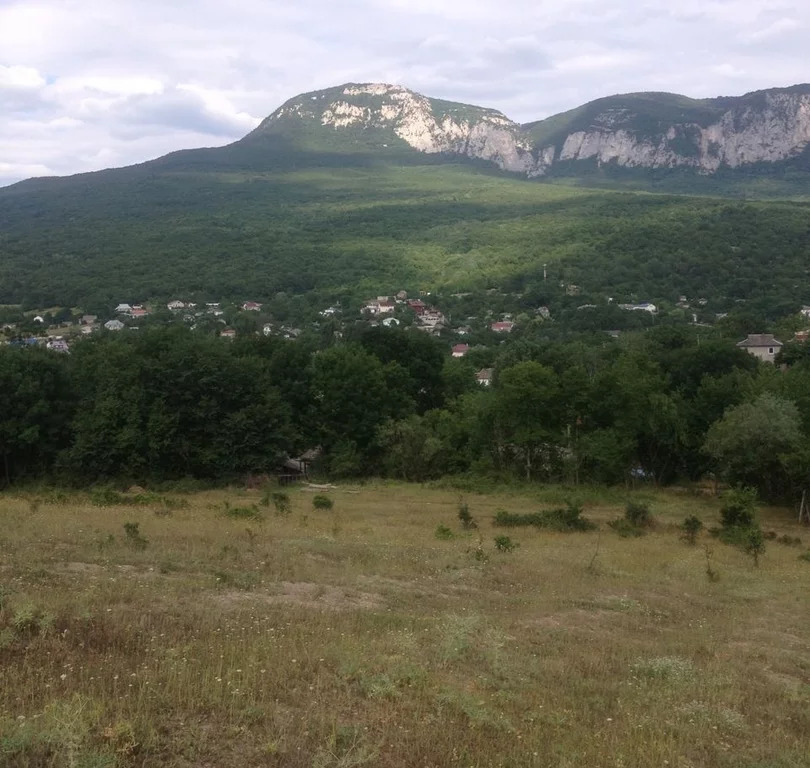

left=558, top=93, right=810, bottom=173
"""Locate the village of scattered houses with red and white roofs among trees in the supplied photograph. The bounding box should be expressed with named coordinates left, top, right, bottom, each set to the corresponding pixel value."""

left=0, top=284, right=810, bottom=372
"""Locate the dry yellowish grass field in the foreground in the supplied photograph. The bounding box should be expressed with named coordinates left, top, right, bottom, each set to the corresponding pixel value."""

left=0, top=484, right=810, bottom=768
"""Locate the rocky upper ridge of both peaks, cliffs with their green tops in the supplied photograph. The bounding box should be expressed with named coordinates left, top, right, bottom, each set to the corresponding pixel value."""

left=258, top=83, right=810, bottom=177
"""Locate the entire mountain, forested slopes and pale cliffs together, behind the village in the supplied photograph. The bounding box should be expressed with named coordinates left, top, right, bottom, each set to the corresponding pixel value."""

left=0, top=79, right=810, bottom=308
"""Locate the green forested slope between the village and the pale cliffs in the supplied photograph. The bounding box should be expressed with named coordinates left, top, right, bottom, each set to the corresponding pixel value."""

left=0, top=158, right=810, bottom=306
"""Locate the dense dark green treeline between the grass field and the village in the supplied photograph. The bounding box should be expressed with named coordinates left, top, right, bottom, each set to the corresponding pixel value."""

left=0, top=326, right=810, bottom=499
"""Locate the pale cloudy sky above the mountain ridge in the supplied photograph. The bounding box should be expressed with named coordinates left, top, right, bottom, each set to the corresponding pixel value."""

left=0, top=0, right=810, bottom=184
